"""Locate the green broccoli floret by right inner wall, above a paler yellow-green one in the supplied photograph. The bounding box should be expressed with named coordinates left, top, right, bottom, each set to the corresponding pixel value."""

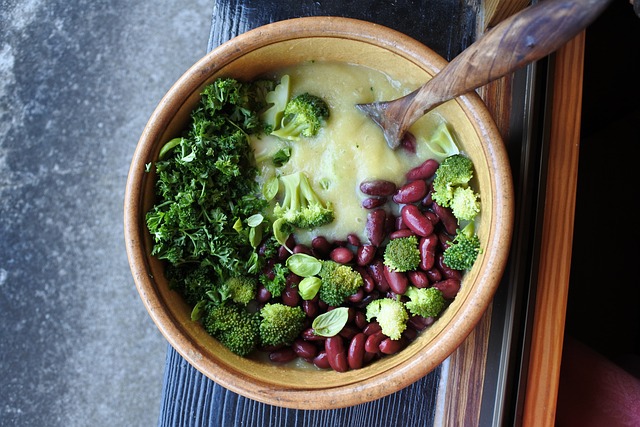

left=432, top=154, right=473, bottom=207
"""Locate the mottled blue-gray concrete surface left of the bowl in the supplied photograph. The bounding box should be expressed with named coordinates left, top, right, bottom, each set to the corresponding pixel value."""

left=0, top=0, right=213, bottom=427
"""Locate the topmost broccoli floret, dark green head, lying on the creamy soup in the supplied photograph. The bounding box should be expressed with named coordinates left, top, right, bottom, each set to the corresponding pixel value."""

left=272, top=93, right=329, bottom=141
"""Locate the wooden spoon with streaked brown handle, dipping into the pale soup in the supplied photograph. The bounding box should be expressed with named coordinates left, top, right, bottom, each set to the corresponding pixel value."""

left=357, top=0, right=611, bottom=149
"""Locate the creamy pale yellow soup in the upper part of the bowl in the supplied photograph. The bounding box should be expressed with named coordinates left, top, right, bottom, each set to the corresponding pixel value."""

left=252, top=62, right=443, bottom=244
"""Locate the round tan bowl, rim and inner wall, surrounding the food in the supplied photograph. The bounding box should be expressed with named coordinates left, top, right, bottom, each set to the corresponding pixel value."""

left=124, top=17, right=513, bottom=409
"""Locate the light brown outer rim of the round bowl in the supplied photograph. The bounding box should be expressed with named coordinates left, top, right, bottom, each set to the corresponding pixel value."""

left=124, top=16, right=513, bottom=409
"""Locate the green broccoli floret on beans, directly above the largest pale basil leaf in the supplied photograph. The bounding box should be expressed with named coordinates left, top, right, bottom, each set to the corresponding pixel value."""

left=318, top=261, right=364, bottom=307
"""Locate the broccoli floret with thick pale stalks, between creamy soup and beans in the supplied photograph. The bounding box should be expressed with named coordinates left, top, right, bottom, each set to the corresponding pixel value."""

left=273, top=172, right=334, bottom=229
